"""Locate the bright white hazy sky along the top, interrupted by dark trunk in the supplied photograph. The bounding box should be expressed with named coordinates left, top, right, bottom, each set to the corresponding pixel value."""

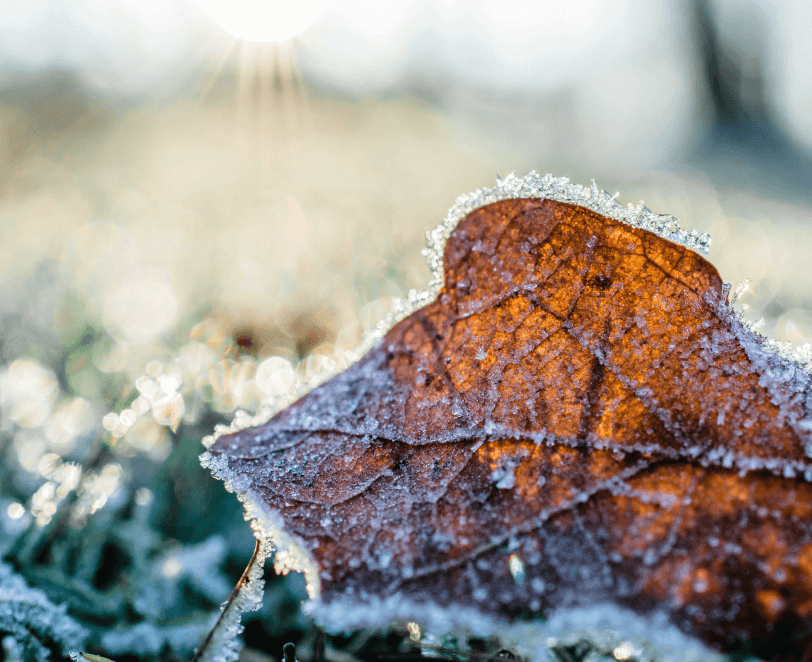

left=0, top=0, right=812, bottom=147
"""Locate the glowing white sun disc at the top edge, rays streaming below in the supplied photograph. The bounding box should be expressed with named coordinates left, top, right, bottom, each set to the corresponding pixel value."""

left=198, top=0, right=327, bottom=43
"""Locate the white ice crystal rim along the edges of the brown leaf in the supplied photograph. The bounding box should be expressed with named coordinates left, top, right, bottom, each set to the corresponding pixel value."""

left=200, top=171, right=800, bottom=662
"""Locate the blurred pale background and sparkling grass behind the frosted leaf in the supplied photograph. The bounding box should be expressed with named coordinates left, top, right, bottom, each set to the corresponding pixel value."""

left=0, top=0, right=812, bottom=659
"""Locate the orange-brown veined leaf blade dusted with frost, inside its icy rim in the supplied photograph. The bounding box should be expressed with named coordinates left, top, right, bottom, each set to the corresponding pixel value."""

left=207, top=182, right=812, bottom=660
